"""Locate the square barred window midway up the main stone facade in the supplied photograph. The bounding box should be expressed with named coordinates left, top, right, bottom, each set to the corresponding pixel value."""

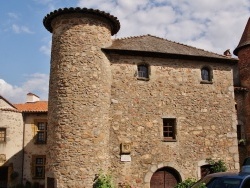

left=163, top=118, right=176, bottom=141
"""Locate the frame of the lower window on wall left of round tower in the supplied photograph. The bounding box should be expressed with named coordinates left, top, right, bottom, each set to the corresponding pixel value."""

left=32, top=155, right=46, bottom=179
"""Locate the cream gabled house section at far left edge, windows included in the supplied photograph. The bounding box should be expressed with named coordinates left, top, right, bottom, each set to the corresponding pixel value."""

left=0, top=95, right=24, bottom=187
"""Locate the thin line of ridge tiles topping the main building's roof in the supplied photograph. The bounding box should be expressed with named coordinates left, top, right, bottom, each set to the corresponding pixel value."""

left=115, top=34, right=235, bottom=59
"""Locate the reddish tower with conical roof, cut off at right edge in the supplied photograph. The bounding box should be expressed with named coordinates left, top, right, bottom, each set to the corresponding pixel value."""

left=234, top=18, right=250, bottom=156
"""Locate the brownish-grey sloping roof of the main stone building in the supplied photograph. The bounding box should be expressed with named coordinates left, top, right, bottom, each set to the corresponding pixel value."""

left=103, top=35, right=237, bottom=63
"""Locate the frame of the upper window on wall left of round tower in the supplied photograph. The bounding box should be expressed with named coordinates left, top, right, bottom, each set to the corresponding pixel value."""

left=35, top=120, right=48, bottom=144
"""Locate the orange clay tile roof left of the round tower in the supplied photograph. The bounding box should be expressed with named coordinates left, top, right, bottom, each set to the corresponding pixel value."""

left=14, top=101, right=48, bottom=113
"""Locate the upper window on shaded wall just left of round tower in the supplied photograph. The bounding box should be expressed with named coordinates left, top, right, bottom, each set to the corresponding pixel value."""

left=36, top=121, right=47, bottom=144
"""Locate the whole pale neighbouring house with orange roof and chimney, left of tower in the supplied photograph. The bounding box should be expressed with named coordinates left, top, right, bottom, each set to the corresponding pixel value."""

left=0, top=93, right=48, bottom=188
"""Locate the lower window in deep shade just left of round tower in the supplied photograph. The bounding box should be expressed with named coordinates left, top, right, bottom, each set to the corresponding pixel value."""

left=33, top=155, right=46, bottom=178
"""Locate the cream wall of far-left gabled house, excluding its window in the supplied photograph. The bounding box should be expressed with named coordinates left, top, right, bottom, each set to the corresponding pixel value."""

left=0, top=98, right=23, bottom=186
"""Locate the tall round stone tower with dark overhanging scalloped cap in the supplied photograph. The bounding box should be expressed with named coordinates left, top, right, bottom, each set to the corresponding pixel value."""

left=43, top=8, right=120, bottom=188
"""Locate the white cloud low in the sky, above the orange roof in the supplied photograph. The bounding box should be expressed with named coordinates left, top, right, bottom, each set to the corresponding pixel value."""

left=0, top=73, right=49, bottom=103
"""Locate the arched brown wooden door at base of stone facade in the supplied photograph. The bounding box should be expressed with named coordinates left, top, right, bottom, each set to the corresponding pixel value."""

left=150, top=167, right=181, bottom=188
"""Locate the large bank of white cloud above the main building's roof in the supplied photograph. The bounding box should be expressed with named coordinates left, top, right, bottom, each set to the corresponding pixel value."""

left=78, top=0, right=250, bottom=53
